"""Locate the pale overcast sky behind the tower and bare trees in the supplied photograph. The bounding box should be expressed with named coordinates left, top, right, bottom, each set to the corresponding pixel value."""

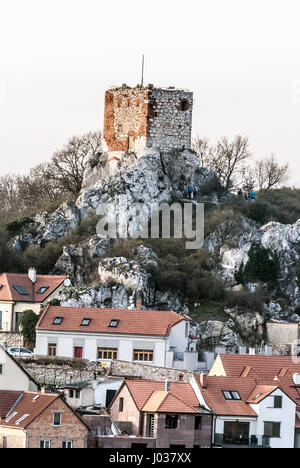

left=0, top=0, right=300, bottom=185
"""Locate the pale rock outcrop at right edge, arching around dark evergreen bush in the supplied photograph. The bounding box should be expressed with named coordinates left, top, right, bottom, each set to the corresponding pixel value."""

left=206, top=218, right=300, bottom=308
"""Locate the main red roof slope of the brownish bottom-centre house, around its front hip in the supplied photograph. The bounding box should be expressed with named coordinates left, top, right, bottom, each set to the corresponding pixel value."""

left=125, top=380, right=200, bottom=411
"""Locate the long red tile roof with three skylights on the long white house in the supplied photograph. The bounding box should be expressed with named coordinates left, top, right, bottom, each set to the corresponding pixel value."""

left=36, top=306, right=187, bottom=336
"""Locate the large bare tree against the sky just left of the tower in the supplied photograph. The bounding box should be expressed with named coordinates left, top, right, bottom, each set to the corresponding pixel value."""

left=44, top=131, right=102, bottom=197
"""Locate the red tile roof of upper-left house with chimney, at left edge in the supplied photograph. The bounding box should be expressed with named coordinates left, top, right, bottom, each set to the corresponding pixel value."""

left=0, top=273, right=67, bottom=303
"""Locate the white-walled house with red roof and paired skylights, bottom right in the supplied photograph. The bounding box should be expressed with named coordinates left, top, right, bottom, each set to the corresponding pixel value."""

left=191, top=374, right=296, bottom=448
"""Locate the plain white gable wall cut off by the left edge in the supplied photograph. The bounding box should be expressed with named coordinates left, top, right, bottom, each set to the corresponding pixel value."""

left=0, top=345, right=39, bottom=392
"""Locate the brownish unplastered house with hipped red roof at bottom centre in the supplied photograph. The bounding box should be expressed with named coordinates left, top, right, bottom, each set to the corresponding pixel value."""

left=110, top=380, right=213, bottom=450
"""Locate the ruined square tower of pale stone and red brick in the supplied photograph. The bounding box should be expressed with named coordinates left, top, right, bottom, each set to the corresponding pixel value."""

left=104, top=84, right=193, bottom=159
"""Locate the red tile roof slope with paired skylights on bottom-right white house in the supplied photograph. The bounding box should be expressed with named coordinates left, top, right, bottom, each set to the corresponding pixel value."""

left=195, top=374, right=257, bottom=417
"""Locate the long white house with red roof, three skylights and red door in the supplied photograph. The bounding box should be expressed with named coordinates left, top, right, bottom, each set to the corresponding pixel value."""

left=35, top=302, right=198, bottom=370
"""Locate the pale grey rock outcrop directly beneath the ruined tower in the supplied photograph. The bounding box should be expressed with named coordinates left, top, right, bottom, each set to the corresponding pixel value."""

left=77, top=150, right=213, bottom=236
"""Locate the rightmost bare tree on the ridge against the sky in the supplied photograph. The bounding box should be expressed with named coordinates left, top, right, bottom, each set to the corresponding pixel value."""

left=254, top=154, right=289, bottom=190
